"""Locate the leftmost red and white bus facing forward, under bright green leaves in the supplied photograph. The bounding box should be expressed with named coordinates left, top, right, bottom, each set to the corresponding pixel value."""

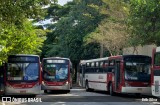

left=4, top=54, right=42, bottom=95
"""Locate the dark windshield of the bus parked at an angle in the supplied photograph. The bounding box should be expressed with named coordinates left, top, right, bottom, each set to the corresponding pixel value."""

left=125, top=58, right=150, bottom=82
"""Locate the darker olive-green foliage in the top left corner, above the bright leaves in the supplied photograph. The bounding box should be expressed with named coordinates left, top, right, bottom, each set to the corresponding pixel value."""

left=0, top=0, right=57, bottom=25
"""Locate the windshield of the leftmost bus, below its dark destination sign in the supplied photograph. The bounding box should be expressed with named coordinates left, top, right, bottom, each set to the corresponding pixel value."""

left=7, top=63, right=39, bottom=81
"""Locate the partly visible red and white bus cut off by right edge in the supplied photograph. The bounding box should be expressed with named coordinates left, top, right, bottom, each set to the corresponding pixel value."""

left=151, top=47, right=160, bottom=97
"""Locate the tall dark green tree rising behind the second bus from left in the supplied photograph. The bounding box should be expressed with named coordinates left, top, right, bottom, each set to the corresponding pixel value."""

left=41, top=0, right=107, bottom=63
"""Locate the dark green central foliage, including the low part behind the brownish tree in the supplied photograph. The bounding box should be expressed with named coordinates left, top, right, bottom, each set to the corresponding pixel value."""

left=42, top=0, right=106, bottom=63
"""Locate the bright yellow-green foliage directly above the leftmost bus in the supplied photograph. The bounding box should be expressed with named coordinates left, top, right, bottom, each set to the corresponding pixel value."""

left=0, top=20, right=45, bottom=61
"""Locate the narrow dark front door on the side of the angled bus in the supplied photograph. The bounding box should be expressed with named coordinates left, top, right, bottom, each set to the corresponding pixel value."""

left=114, top=61, right=121, bottom=91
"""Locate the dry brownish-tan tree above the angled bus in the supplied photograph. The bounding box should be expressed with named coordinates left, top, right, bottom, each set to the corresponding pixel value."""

left=85, top=0, right=129, bottom=57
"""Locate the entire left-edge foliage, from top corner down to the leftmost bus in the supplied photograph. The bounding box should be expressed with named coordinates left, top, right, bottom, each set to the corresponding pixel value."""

left=0, top=0, right=49, bottom=61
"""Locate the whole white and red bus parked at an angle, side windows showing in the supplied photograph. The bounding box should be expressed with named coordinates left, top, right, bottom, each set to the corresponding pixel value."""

left=80, top=55, right=151, bottom=96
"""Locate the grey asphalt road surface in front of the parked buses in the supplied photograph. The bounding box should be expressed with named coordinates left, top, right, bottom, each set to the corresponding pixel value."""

left=1, top=88, right=160, bottom=105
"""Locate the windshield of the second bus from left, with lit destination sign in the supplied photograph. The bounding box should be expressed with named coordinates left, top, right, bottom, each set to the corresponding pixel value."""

left=43, top=63, right=68, bottom=81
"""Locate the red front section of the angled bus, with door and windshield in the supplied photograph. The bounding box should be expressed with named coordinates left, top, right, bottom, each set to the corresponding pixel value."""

left=109, top=55, right=151, bottom=96
